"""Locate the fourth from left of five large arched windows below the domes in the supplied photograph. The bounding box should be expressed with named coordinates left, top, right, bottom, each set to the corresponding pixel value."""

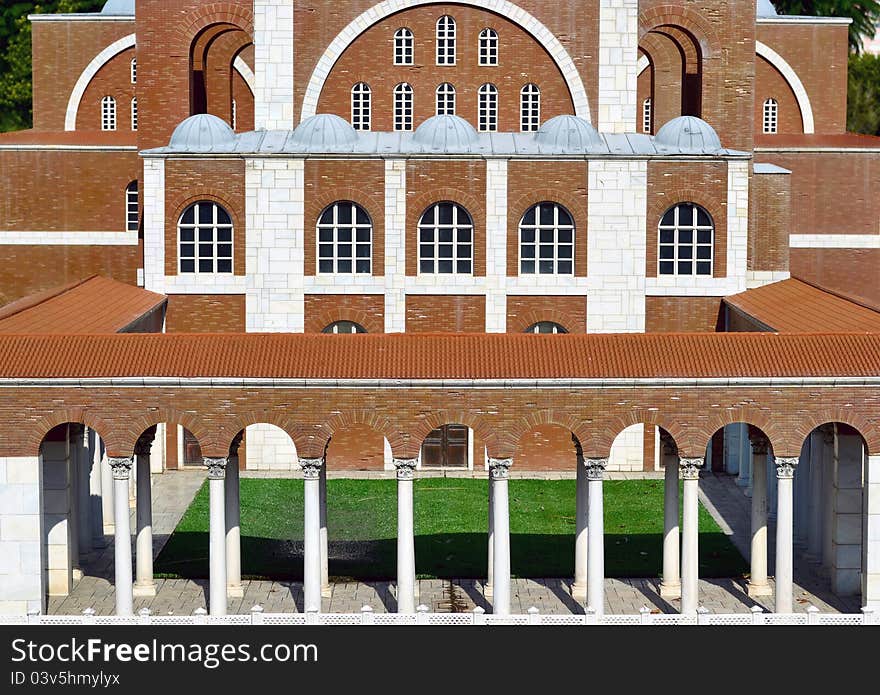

left=519, top=203, right=574, bottom=275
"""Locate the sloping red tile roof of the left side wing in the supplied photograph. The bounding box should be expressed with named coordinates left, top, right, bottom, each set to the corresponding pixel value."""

left=0, top=275, right=166, bottom=334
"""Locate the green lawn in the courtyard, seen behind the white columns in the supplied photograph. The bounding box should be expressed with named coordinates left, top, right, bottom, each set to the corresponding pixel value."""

left=156, top=478, right=747, bottom=579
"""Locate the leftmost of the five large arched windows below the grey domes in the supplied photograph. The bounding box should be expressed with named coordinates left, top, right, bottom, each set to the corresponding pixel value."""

left=177, top=200, right=232, bottom=273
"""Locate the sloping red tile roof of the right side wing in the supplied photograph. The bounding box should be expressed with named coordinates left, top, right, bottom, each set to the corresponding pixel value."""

left=724, top=278, right=880, bottom=333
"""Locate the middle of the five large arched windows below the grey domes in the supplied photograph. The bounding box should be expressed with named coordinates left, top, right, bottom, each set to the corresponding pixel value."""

left=419, top=202, right=474, bottom=275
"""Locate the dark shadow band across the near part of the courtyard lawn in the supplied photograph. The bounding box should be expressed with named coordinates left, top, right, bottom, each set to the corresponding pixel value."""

left=155, top=532, right=748, bottom=581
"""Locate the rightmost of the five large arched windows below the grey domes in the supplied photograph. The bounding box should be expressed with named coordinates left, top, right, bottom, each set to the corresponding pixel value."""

left=658, top=203, right=715, bottom=275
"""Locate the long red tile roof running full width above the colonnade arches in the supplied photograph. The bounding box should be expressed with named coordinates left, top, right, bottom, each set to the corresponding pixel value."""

left=0, top=333, right=880, bottom=380
